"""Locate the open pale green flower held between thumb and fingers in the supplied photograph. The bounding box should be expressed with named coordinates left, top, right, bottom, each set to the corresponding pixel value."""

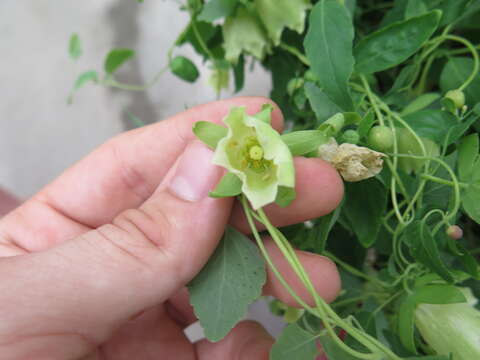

left=213, top=107, right=295, bottom=209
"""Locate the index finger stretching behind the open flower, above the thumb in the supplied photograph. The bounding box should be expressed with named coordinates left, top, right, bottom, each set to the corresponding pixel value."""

left=0, top=97, right=283, bottom=251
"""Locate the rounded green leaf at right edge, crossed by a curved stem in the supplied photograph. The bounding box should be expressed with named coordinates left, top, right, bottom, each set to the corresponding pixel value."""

left=440, top=57, right=480, bottom=106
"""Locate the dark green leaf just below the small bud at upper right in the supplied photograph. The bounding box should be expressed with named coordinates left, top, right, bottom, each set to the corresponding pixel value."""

left=404, top=109, right=458, bottom=144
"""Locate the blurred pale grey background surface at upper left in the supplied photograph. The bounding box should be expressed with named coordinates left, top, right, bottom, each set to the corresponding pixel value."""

left=0, top=0, right=271, bottom=197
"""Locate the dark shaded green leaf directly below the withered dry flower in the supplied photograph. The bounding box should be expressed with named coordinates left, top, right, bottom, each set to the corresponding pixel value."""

left=343, top=178, right=387, bottom=248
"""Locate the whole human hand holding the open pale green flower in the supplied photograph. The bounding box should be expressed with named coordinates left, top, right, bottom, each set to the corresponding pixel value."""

left=0, top=98, right=343, bottom=360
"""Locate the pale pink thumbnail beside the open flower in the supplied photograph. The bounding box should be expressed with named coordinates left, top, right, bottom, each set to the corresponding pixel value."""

left=169, top=142, right=220, bottom=202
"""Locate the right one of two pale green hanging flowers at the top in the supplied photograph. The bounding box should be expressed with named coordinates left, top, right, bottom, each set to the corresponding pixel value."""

left=255, top=0, right=310, bottom=45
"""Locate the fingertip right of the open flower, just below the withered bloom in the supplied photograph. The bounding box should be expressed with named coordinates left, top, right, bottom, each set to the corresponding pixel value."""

left=231, top=157, right=343, bottom=233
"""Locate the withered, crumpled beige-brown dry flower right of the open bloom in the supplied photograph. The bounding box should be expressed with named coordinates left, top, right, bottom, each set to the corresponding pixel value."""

left=318, top=138, right=386, bottom=182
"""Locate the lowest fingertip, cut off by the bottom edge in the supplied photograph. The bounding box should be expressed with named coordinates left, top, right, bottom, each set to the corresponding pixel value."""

left=196, top=321, right=273, bottom=360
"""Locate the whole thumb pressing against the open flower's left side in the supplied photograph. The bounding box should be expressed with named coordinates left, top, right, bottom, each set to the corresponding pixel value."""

left=0, top=142, right=232, bottom=343
